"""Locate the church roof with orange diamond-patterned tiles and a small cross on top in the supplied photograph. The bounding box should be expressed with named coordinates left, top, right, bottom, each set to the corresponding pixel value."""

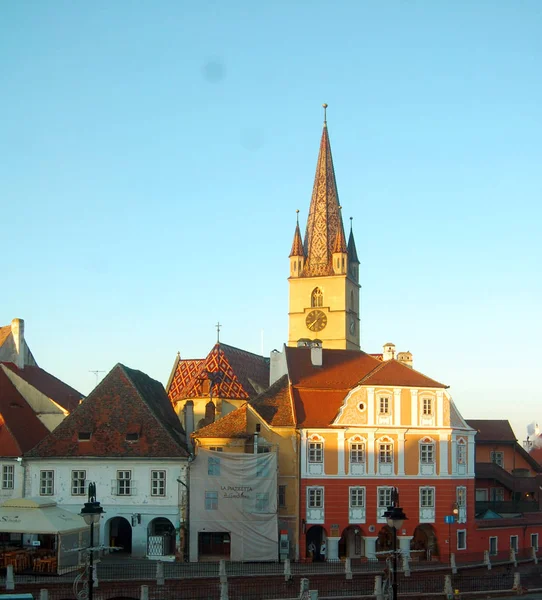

left=168, top=343, right=269, bottom=402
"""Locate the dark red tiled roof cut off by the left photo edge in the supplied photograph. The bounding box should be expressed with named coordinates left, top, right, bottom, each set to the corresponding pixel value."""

left=0, top=368, right=49, bottom=456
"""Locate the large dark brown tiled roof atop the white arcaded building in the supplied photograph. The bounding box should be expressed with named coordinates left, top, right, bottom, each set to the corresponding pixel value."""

left=27, top=363, right=188, bottom=458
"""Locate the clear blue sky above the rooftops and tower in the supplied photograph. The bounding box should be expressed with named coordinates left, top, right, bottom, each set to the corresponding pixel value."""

left=0, top=0, right=542, bottom=438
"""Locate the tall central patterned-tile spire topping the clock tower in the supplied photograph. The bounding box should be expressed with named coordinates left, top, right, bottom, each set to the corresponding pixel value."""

left=303, top=104, right=345, bottom=277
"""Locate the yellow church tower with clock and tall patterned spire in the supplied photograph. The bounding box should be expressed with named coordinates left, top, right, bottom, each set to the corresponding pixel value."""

left=288, top=104, right=360, bottom=350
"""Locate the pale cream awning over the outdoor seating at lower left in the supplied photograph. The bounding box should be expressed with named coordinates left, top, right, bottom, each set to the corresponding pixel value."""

left=0, top=498, right=88, bottom=534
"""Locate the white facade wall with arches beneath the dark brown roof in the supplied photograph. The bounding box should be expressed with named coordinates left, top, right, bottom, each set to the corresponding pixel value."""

left=26, top=458, right=186, bottom=556
